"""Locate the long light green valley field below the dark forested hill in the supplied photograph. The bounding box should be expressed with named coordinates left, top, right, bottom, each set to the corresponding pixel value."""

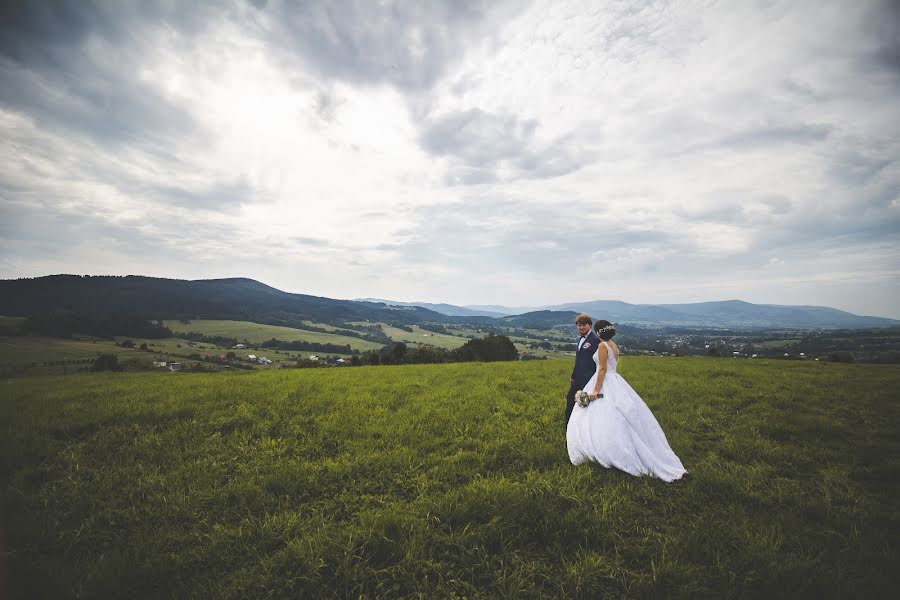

left=164, top=320, right=382, bottom=351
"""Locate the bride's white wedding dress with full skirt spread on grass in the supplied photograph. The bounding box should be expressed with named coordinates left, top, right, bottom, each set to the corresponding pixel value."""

left=566, top=342, right=687, bottom=481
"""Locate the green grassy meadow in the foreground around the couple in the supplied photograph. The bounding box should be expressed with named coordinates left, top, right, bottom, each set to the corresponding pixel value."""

left=0, top=356, right=900, bottom=599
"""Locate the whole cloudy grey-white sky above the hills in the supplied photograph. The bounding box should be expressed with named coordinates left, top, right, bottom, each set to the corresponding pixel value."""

left=0, top=0, right=900, bottom=318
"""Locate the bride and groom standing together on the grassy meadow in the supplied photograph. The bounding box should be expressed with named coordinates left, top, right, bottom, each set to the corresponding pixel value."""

left=566, top=314, right=687, bottom=481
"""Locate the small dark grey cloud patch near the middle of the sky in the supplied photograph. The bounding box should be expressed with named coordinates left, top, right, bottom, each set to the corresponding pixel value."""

left=421, top=108, right=588, bottom=184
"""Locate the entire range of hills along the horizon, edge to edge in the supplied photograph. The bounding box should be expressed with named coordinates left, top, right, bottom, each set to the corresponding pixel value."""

left=0, top=275, right=900, bottom=329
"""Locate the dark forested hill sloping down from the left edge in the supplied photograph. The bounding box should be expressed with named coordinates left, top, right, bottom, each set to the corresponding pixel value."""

left=0, top=275, right=453, bottom=324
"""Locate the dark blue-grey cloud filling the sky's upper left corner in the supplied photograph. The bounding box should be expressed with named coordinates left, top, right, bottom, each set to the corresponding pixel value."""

left=0, top=0, right=220, bottom=146
